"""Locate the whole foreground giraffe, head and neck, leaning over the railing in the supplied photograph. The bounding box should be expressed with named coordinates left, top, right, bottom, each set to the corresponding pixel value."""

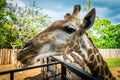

left=17, top=5, right=115, bottom=80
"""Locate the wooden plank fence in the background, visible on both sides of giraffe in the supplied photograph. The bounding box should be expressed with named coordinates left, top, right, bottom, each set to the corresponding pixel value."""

left=0, top=49, right=120, bottom=65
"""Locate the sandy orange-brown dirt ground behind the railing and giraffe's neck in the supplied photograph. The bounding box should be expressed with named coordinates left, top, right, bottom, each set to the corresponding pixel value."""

left=0, top=65, right=120, bottom=80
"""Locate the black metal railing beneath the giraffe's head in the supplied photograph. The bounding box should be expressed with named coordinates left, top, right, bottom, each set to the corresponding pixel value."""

left=0, top=58, right=102, bottom=80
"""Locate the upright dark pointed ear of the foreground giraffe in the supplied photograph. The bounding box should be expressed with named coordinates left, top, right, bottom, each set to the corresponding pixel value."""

left=82, top=8, right=96, bottom=30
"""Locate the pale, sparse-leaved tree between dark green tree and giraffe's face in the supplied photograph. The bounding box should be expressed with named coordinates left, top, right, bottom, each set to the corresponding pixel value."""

left=8, top=2, right=50, bottom=47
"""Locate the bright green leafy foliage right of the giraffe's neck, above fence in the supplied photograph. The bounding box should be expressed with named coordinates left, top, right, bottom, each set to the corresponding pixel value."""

left=88, top=18, right=120, bottom=48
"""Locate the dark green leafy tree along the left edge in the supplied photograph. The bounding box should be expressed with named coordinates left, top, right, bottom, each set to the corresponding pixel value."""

left=0, top=0, right=16, bottom=48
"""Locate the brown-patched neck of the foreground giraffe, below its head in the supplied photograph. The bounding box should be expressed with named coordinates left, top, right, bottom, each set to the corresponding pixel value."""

left=79, top=34, right=115, bottom=80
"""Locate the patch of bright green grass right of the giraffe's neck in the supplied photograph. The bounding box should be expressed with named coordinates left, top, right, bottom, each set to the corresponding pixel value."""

left=104, top=58, right=120, bottom=69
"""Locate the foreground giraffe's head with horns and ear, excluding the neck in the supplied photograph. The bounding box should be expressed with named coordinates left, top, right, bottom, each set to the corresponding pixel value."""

left=17, top=5, right=95, bottom=65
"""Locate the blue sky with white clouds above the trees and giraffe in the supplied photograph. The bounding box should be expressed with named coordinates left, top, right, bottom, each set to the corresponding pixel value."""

left=7, top=0, right=120, bottom=24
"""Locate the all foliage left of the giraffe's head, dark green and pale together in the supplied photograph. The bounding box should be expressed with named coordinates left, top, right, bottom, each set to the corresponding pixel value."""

left=0, top=0, right=50, bottom=48
